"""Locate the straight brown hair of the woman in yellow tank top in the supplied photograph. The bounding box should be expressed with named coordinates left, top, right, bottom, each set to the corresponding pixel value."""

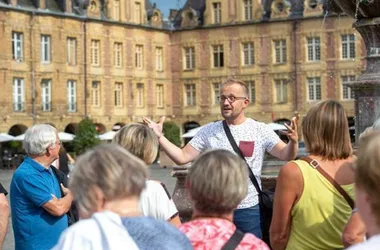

left=302, top=100, right=352, bottom=160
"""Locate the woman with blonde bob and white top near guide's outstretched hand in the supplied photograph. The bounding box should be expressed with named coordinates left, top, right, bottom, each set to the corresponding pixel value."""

left=112, top=123, right=181, bottom=226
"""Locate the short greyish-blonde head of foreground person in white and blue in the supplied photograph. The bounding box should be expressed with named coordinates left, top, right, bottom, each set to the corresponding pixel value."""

left=69, top=144, right=147, bottom=218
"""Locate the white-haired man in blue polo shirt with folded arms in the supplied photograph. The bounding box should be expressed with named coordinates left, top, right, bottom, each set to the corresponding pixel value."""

left=10, top=124, right=73, bottom=250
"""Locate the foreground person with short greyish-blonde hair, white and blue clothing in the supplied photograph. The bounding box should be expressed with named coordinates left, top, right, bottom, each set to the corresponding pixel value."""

left=53, top=144, right=191, bottom=250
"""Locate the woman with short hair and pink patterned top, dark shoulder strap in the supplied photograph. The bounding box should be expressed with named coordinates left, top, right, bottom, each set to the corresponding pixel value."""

left=180, top=149, right=269, bottom=250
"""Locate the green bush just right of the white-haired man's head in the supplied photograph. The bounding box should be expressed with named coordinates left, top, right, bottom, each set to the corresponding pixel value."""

left=73, top=118, right=100, bottom=155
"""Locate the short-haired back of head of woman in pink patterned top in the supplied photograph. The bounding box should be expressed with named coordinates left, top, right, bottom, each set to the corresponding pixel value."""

left=186, top=149, right=248, bottom=214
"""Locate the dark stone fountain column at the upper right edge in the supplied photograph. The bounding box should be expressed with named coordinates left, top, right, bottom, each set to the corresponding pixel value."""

left=325, top=0, right=380, bottom=141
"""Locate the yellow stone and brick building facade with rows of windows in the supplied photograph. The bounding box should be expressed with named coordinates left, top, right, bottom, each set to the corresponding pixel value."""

left=0, top=0, right=365, bottom=135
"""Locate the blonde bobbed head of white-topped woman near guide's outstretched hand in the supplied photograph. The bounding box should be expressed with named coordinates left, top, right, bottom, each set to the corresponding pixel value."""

left=112, top=123, right=158, bottom=164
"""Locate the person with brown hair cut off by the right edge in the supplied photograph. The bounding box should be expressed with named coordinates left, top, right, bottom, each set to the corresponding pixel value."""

left=349, top=131, right=380, bottom=250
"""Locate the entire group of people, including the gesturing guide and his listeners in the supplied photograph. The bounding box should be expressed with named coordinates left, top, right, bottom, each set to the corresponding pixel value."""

left=0, top=79, right=380, bottom=250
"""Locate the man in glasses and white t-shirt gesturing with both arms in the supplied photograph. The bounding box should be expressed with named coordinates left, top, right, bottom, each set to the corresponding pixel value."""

left=143, top=79, right=298, bottom=237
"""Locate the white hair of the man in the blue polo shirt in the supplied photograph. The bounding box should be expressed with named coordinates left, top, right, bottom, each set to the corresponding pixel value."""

left=23, top=124, right=58, bottom=155
